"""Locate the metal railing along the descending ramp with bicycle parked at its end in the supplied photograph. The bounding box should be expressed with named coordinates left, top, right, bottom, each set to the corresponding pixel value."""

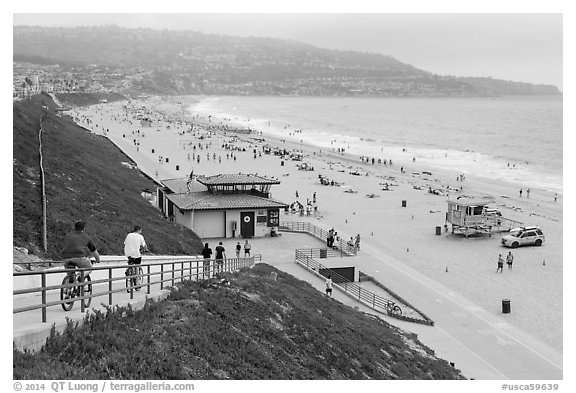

left=296, top=249, right=402, bottom=315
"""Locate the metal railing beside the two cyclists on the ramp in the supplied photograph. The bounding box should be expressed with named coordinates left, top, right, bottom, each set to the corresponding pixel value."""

left=12, top=254, right=262, bottom=322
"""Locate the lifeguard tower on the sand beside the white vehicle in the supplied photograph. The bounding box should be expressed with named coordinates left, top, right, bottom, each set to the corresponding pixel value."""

left=446, top=198, right=522, bottom=237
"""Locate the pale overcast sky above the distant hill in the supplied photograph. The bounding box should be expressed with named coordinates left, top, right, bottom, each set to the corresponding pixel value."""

left=13, top=13, right=563, bottom=90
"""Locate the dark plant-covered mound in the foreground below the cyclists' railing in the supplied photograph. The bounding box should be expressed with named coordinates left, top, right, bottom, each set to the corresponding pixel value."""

left=13, top=264, right=463, bottom=380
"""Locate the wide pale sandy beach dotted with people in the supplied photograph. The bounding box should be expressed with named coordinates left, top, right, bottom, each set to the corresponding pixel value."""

left=70, top=97, right=563, bottom=351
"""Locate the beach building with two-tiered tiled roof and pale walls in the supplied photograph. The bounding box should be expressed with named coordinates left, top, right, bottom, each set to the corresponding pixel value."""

left=157, top=173, right=288, bottom=238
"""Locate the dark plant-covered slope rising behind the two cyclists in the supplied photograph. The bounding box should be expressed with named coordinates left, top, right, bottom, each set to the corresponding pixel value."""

left=12, top=95, right=202, bottom=260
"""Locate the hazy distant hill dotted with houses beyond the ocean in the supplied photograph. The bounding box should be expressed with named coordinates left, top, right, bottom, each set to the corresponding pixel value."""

left=13, top=26, right=560, bottom=96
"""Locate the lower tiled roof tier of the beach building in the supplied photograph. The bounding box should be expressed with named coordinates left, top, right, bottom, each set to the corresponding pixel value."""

left=166, top=191, right=288, bottom=211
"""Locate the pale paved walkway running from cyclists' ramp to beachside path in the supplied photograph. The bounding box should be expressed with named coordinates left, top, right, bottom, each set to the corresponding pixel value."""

left=13, top=233, right=563, bottom=380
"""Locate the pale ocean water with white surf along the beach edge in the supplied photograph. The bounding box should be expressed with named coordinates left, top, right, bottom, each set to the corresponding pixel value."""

left=188, top=96, right=563, bottom=193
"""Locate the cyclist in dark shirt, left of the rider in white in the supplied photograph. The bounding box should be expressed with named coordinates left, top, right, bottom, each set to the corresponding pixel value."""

left=62, top=221, right=100, bottom=283
